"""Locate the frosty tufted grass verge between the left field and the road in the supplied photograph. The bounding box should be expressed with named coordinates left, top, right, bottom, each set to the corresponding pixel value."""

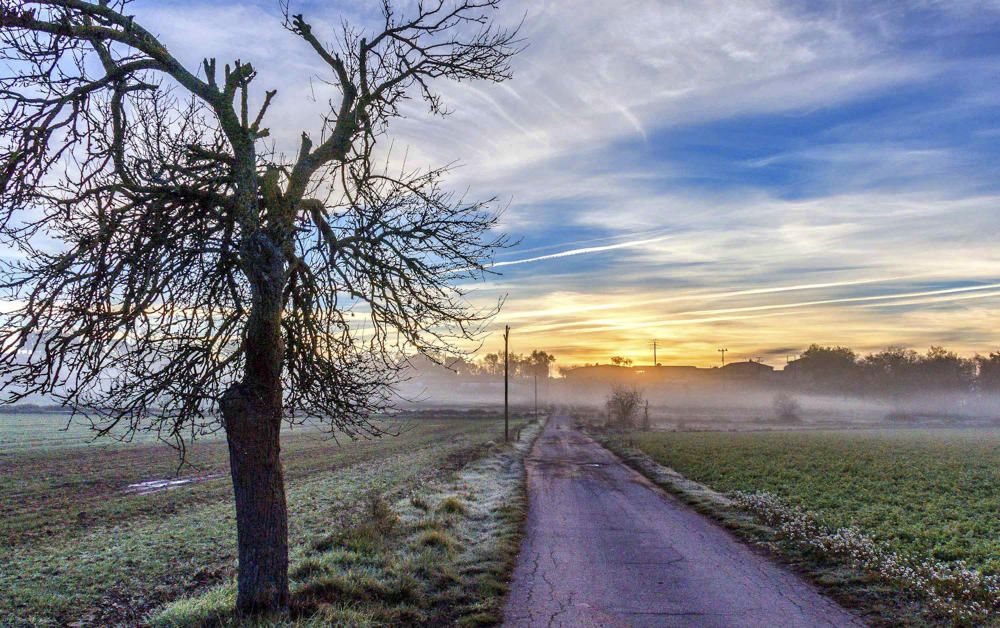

left=150, top=421, right=543, bottom=626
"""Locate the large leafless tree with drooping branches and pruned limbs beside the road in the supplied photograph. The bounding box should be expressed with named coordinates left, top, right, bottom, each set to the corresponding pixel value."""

left=0, top=0, right=518, bottom=612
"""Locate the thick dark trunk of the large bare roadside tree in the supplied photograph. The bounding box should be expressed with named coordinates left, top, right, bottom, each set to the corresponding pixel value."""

left=220, top=233, right=289, bottom=614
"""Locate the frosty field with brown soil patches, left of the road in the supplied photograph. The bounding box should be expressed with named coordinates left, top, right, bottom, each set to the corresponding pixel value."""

left=0, top=417, right=532, bottom=625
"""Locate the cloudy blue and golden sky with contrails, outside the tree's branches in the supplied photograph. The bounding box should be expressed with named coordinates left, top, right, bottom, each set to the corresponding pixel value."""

left=132, top=0, right=1000, bottom=367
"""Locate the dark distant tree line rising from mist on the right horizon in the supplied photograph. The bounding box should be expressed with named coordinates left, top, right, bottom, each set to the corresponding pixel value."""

left=785, top=344, right=1000, bottom=395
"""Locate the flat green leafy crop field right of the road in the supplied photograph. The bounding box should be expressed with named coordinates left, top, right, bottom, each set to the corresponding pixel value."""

left=635, top=429, right=1000, bottom=574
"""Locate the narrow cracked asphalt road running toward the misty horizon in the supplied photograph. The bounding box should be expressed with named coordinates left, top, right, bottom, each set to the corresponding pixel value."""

left=504, top=414, right=864, bottom=627
